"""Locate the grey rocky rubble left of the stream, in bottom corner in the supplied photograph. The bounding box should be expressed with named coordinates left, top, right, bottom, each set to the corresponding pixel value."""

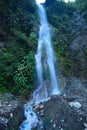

left=0, top=93, right=25, bottom=130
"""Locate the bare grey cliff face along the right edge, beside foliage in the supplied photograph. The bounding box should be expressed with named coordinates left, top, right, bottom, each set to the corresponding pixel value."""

left=64, top=11, right=87, bottom=78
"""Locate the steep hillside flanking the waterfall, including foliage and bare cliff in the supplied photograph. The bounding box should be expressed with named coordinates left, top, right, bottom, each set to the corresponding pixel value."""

left=0, top=0, right=87, bottom=96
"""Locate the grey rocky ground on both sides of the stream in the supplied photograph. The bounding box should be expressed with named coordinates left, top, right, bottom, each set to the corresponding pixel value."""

left=0, top=77, right=87, bottom=130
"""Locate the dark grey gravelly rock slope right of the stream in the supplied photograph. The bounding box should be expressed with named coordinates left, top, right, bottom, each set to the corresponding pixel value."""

left=35, top=77, right=87, bottom=130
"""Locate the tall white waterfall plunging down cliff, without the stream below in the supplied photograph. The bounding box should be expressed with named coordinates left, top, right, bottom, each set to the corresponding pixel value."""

left=33, top=3, right=60, bottom=103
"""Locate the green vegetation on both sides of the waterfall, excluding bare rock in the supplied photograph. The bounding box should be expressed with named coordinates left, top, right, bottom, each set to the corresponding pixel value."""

left=0, top=0, right=87, bottom=95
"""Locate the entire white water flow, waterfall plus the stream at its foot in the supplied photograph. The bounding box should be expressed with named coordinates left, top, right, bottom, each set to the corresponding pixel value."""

left=20, top=0, right=60, bottom=130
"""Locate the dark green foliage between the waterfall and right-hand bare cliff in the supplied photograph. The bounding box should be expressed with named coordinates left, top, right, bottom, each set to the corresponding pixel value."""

left=46, top=0, right=87, bottom=75
